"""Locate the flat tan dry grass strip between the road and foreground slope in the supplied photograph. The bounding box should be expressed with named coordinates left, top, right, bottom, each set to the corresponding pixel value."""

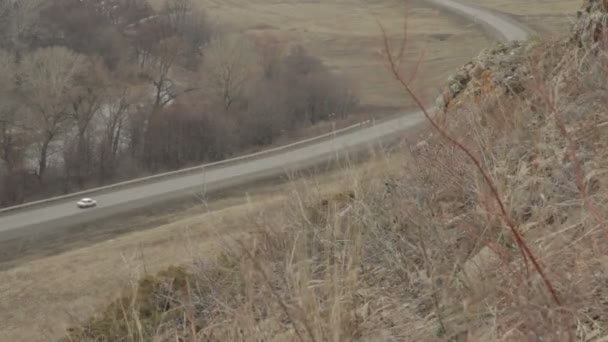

left=0, top=182, right=294, bottom=341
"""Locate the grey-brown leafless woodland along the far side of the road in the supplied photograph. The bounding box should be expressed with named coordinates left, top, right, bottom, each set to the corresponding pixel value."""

left=0, top=0, right=357, bottom=206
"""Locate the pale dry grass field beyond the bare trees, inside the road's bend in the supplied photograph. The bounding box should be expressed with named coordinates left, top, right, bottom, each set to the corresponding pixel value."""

left=178, top=0, right=491, bottom=108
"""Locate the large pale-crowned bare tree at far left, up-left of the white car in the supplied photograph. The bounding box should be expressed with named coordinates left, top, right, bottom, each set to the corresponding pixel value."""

left=19, top=47, right=84, bottom=179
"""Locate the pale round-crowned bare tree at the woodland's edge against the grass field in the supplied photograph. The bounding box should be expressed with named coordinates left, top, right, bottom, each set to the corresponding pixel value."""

left=201, top=35, right=259, bottom=110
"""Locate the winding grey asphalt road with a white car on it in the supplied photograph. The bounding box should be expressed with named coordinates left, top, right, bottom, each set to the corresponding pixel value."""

left=0, top=0, right=528, bottom=241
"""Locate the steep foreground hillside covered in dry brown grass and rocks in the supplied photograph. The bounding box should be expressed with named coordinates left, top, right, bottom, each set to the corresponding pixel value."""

left=7, top=0, right=608, bottom=342
